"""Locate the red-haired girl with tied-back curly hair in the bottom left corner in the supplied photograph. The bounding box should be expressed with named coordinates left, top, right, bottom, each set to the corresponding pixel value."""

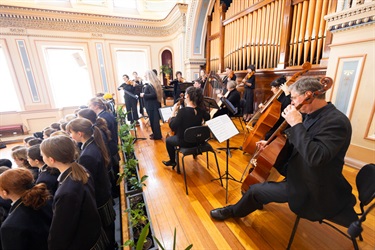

left=0, top=168, right=52, bottom=250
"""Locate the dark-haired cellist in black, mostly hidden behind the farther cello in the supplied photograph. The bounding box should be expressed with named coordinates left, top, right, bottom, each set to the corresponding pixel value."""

left=259, top=76, right=290, bottom=140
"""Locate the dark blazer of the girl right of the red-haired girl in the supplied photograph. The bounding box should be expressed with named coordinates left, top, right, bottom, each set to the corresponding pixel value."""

left=48, top=168, right=101, bottom=250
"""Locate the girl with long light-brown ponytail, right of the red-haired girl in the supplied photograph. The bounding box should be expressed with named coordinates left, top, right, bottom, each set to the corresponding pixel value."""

left=40, top=135, right=109, bottom=249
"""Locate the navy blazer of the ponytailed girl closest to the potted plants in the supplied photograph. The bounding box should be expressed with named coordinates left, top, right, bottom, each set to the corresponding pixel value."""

left=78, top=137, right=111, bottom=207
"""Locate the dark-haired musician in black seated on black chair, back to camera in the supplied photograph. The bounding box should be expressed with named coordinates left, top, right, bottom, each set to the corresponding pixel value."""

left=163, top=86, right=210, bottom=168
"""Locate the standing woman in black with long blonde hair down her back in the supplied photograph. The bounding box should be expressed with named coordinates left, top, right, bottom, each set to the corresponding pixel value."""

left=141, top=70, right=163, bottom=140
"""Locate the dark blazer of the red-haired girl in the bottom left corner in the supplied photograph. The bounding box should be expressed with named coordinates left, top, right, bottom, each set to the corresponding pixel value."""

left=0, top=199, right=52, bottom=250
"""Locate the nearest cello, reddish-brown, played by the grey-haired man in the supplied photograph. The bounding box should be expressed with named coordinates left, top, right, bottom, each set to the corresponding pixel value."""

left=241, top=77, right=333, bottom=193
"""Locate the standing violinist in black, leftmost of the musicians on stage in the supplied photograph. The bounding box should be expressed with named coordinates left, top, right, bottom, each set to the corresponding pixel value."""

left=117, top=75, right=139, bottom=125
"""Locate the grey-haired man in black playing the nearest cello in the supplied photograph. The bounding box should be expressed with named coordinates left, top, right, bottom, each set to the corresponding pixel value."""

left=211, top=78, right=358, bottom=226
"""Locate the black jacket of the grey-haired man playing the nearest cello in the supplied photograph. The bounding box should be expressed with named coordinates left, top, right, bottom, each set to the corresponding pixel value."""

left=286, top=103, right=355, bottom=220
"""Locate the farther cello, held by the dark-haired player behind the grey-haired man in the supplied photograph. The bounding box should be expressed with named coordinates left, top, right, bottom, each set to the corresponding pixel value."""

left=242, top=62, right=311, bottom=154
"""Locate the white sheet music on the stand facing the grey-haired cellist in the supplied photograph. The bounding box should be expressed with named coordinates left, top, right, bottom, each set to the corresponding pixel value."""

left=206, top=115, right=240, bottom=143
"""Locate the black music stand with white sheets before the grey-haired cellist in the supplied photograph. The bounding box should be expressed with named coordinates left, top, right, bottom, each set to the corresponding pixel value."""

left=206, top=115, right=240, bottom=203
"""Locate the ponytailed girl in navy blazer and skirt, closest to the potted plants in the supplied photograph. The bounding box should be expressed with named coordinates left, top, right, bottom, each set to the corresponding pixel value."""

left=66, top=118, right=116, bottom=245
